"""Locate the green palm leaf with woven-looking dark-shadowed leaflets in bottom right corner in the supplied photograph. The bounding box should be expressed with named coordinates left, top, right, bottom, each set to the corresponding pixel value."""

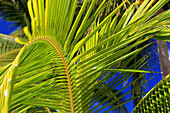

left=132, top=75, right=170, bottom=113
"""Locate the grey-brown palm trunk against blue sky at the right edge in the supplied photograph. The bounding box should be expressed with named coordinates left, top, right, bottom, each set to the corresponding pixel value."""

left=158, top=40, right=170, bottom=77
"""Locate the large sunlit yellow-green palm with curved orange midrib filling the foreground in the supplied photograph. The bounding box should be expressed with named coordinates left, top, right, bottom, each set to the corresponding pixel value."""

left=0, top=0, right=170, bottom=113
